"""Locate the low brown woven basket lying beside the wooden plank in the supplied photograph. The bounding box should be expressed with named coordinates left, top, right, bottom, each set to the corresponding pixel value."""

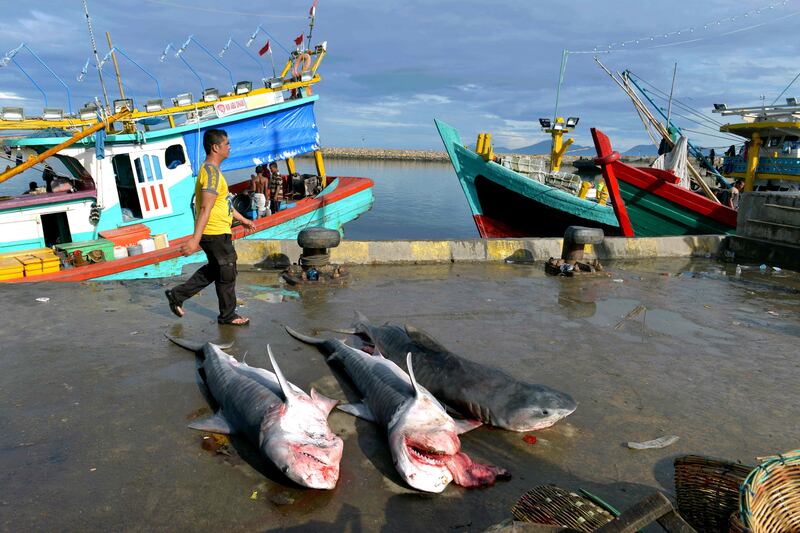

left=511, top=485, right=614, bottom=531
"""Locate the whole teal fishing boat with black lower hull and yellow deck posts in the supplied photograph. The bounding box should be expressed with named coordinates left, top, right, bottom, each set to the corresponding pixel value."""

left=435, top=121, right=620, bottom=238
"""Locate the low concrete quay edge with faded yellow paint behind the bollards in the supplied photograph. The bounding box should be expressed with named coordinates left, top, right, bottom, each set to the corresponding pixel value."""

left=235, top=235, right=725, bottom=267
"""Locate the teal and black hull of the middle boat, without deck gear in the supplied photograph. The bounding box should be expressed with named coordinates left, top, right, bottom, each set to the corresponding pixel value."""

left=435, top=120, right=619, bottom=238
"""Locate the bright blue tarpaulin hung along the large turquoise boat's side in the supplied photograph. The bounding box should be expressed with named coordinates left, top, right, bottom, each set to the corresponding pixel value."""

left=183, top=102, right=319, bottom=173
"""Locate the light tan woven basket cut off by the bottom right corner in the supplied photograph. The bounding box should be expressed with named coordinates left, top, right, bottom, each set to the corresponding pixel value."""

left=739, top=450, right=800, bottom=533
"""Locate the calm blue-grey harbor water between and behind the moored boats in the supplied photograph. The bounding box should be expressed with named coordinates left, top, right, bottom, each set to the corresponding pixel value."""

left=0, top=159, right=478, bottom=240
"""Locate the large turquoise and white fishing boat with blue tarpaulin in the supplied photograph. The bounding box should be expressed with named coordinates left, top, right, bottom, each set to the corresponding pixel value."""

left=0, top=28, right=373, bottom=282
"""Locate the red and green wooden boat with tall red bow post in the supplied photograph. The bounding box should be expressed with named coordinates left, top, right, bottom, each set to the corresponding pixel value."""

left=591, top=128, right=736, bottom=237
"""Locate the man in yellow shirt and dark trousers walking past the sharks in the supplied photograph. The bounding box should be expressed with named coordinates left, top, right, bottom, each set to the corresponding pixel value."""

left=165, top=129, right=255, bottom=326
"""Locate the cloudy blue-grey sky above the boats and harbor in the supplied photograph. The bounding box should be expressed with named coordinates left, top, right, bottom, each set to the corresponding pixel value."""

left=0, top=0, right=800, bottom=155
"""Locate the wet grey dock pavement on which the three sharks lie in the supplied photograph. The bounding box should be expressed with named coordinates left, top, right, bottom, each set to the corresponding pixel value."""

left=0, top=260, right=800, bottom=532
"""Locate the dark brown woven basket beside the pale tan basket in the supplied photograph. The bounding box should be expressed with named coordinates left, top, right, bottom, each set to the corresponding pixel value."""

left=674, top=455, right=753, bottom=533
